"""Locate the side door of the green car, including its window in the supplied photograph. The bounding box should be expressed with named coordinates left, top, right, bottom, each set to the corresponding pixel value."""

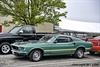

left=46, top=36, right=75, bottom=55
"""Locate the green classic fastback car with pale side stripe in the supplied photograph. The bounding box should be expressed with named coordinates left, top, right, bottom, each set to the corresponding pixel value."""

left=12, top=34, right=92, bottom=61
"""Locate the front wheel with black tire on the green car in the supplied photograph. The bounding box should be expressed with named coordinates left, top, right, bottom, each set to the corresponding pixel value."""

left=29, top=50, right=43, bottom=62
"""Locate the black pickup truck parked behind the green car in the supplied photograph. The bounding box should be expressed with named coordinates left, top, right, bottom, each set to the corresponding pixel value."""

left=0, top=25, right=49, bottom=54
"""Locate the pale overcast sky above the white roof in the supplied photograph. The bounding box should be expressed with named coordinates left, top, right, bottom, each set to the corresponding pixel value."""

left=66, top=0, right=100, bottom=22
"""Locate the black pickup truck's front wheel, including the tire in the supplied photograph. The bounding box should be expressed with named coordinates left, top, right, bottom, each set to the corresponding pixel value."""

left=0, top=42, right=11, bottom=54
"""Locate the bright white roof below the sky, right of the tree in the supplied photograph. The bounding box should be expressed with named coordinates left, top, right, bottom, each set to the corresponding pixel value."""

left=59, top=19, right=100, bottom=33
